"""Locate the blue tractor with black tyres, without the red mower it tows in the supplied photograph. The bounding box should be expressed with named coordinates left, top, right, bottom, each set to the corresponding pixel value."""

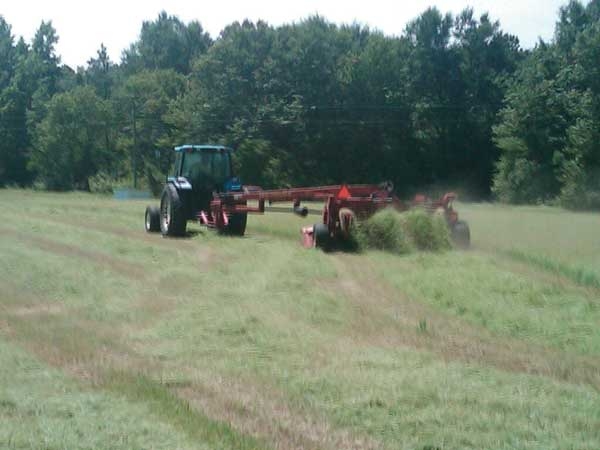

left=145, top=145, right=247, bottom=236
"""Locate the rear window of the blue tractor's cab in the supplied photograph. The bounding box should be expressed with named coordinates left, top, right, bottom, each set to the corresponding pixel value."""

left=181, top=150, right=231, bottom=185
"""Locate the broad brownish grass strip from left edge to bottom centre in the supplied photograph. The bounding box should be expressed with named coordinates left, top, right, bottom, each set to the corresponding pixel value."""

left=0, top=270, right=382, bottom=450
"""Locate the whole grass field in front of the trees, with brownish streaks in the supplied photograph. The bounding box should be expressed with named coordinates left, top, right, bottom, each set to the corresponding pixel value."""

left=0, top=190, right=600, bottom=449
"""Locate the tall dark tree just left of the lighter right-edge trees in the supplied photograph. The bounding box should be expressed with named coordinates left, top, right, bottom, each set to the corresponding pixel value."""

left=449, top=9, right=523, bottom=194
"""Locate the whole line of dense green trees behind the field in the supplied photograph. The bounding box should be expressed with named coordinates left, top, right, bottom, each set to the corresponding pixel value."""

left=0, top=0, right=600, bottom=208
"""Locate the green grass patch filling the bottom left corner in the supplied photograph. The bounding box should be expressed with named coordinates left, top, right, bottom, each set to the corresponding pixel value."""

left=0, top=338, right=216, bottom=450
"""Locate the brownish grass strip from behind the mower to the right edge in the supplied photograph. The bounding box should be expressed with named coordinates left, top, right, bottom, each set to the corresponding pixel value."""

left=323, top=255, right=600, bottom=391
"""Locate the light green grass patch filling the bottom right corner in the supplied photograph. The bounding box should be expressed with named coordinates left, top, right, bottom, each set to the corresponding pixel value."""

left=293, top=347, right=600, bottom=449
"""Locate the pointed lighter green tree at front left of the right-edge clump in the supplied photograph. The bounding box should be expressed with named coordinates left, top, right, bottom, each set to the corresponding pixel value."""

left=494, top=43, right=573, bottom=203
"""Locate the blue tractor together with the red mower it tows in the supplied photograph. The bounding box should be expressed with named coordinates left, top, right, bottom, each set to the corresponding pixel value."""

left=145, top=145, right=470, bottom=248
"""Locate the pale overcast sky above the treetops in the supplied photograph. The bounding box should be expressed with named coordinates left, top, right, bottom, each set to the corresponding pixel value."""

left=0, top=0, right=567, bottom=67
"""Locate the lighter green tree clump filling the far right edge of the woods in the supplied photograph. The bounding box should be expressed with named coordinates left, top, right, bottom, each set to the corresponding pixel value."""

left=493, top=1, right=600, bottom=209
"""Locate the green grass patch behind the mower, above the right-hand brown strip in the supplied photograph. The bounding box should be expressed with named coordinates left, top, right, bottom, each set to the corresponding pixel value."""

left=371, top=253, right=600, bottom=355
